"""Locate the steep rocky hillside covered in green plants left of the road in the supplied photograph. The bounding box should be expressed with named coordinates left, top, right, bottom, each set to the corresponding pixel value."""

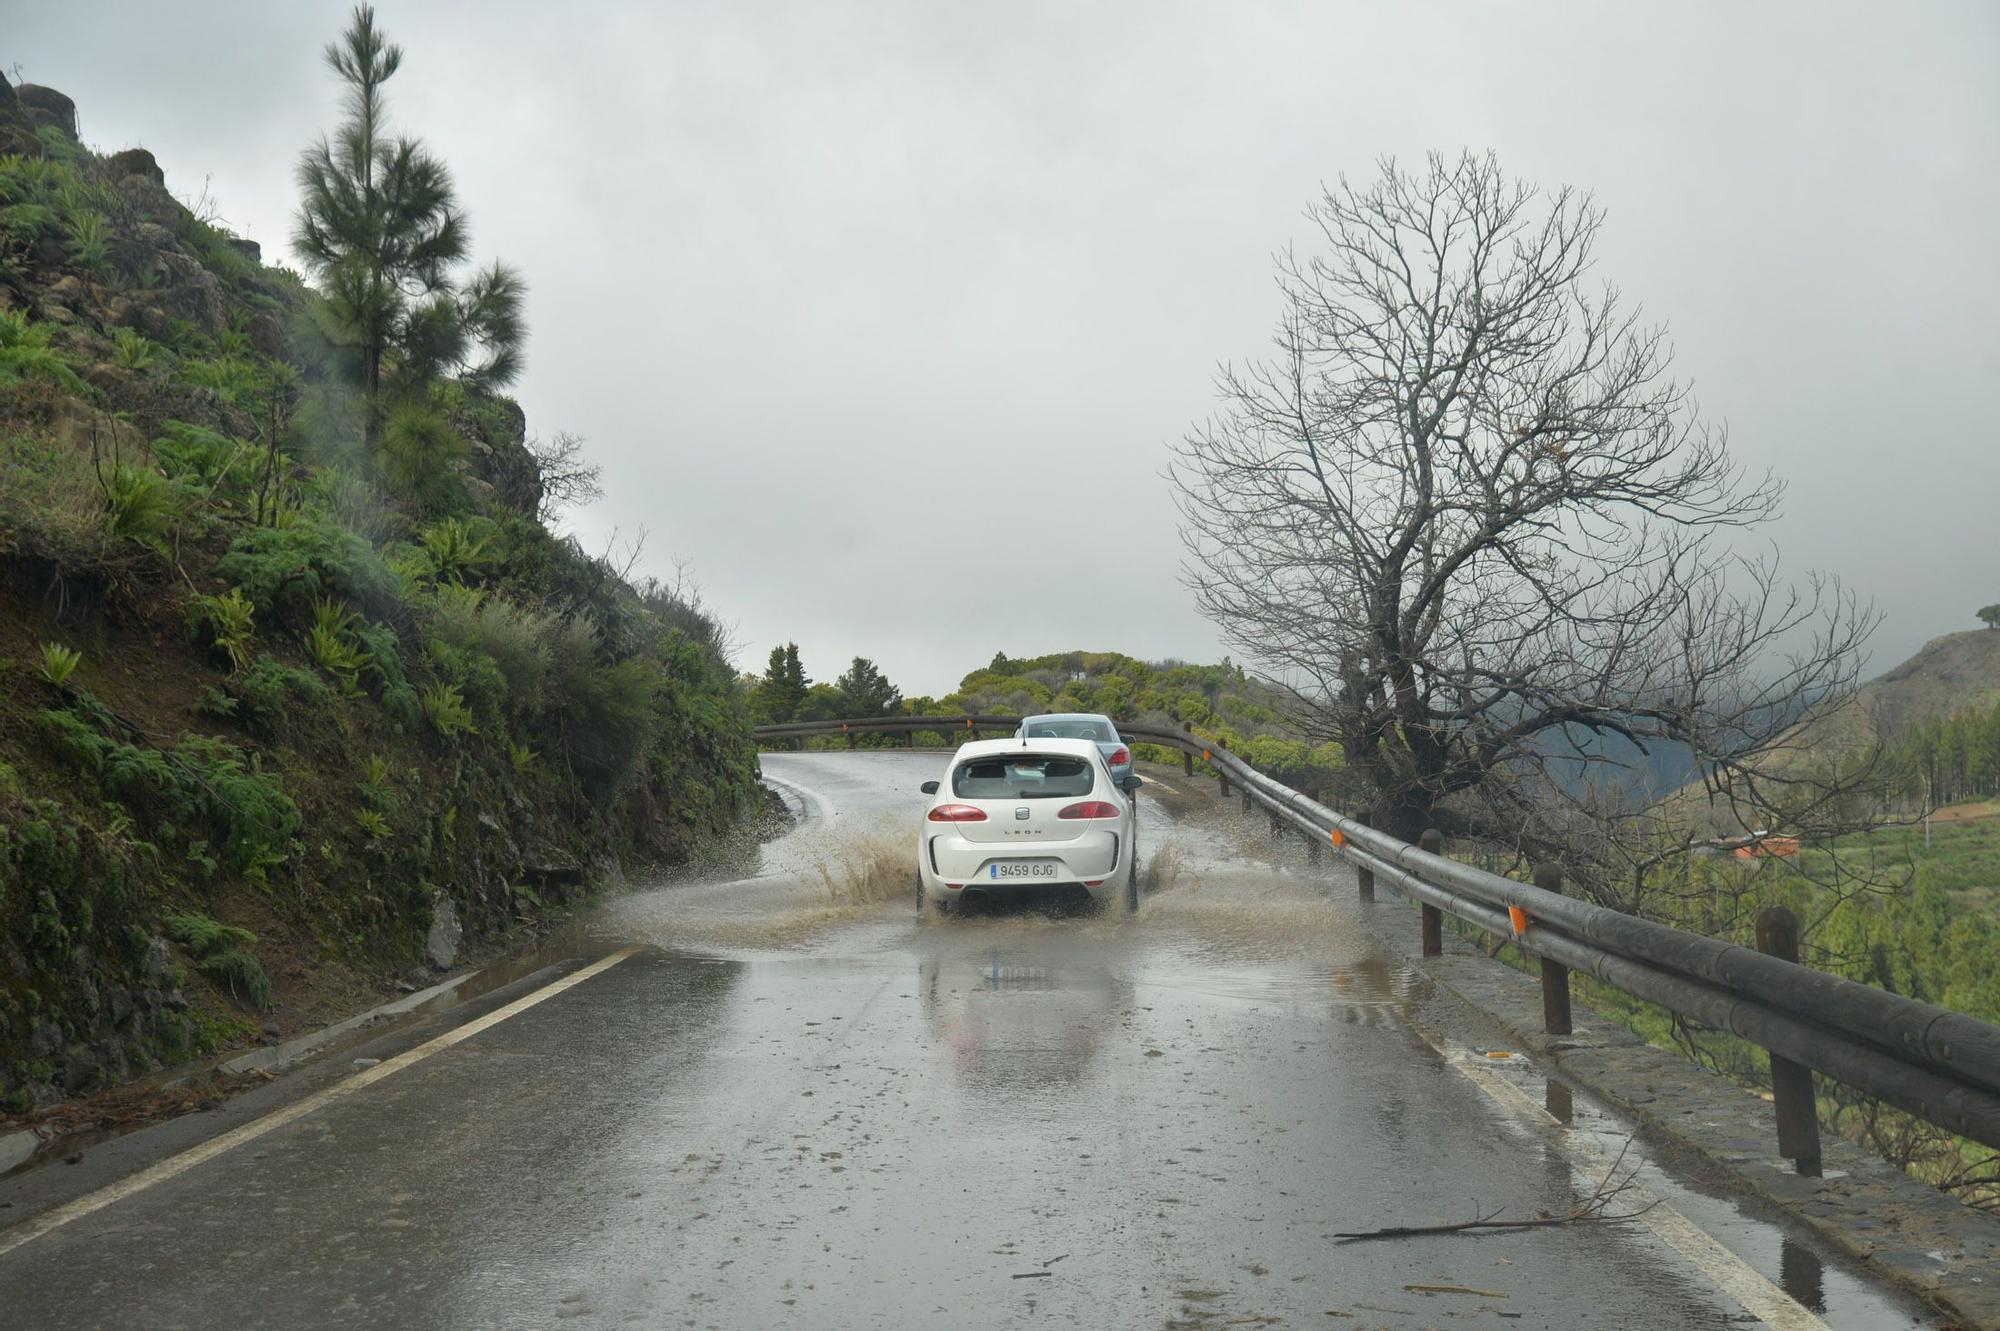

left=0, top=80, right=756, bottom=1113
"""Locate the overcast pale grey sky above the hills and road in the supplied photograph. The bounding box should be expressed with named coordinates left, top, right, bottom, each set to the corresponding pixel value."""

left=0, top=0, right=2000, bottom=693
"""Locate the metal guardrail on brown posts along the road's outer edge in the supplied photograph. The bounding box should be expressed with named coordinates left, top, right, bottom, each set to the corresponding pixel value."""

left=756, top=715, right=2000, bottom=1173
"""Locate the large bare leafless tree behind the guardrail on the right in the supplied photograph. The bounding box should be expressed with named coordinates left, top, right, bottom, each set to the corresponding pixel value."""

left=1172, top=154, right=1876, bottom=859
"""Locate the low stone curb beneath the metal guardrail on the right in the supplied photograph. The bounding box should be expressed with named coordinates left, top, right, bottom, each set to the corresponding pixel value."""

left=1342, top=879, right=2000, bottom=1327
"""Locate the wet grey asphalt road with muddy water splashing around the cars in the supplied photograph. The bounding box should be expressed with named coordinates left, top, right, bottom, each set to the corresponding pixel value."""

left=0, top=753, right=1936, bottom=1329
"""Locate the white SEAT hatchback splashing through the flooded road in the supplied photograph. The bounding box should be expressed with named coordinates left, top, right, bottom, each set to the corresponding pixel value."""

left=916, top=739, right=1138, bottom=911
